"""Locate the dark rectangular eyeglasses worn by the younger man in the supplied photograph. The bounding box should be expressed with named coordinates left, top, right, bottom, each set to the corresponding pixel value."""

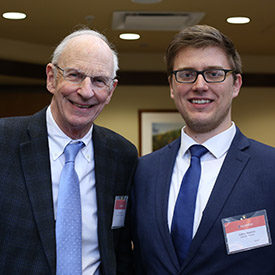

left=171, top=69, right=237, bottom=83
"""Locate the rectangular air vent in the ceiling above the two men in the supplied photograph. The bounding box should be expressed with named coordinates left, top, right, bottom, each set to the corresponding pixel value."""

left=112, top=11, right=205, bottom=31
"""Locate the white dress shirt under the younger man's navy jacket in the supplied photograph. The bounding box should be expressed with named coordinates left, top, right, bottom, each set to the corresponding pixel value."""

left=168, top=122, right=236, bottom=237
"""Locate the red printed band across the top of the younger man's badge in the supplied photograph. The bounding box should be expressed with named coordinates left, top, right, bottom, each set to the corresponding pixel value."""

left=224, top=215, right=266, bottom=234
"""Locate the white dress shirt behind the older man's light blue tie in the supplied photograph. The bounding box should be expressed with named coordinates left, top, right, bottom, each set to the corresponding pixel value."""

left=46, top=106, right=100, bottom=275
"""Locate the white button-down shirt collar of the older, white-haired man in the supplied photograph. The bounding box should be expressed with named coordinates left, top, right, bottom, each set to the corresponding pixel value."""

left=46, top=106, right=93, bottom=161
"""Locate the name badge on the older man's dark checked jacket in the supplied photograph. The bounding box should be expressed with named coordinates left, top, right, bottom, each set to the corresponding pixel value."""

left=112, top=196, right=128, bottom=229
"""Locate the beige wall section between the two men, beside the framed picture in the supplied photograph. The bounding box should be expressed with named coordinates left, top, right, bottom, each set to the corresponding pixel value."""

left=96, top=86, right=175, bottom=152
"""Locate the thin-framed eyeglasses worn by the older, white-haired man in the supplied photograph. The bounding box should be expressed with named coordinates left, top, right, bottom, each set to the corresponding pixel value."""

left=54, top=64, right=114, bottom=90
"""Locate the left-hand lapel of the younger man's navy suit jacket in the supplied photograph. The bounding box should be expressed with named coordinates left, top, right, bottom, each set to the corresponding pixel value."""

left=155, top=138, right=180, bottom=268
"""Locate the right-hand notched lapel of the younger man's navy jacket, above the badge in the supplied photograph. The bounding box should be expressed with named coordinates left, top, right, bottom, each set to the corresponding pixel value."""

left=183, top=128, right=250, bottom=268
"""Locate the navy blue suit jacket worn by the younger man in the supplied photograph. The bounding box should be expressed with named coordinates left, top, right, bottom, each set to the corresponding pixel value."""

left=132, top=129, right=275, bottom=275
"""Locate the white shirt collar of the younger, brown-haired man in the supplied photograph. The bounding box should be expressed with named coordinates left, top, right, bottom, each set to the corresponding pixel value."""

left=179, top=121, right=236, bottom=159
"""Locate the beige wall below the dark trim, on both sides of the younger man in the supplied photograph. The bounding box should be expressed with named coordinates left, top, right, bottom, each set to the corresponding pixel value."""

left=96, top=86, right=275, bottom=153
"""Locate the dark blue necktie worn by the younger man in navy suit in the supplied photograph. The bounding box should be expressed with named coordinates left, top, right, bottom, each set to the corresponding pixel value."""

left=171, top=145, right=208, bottom=265
